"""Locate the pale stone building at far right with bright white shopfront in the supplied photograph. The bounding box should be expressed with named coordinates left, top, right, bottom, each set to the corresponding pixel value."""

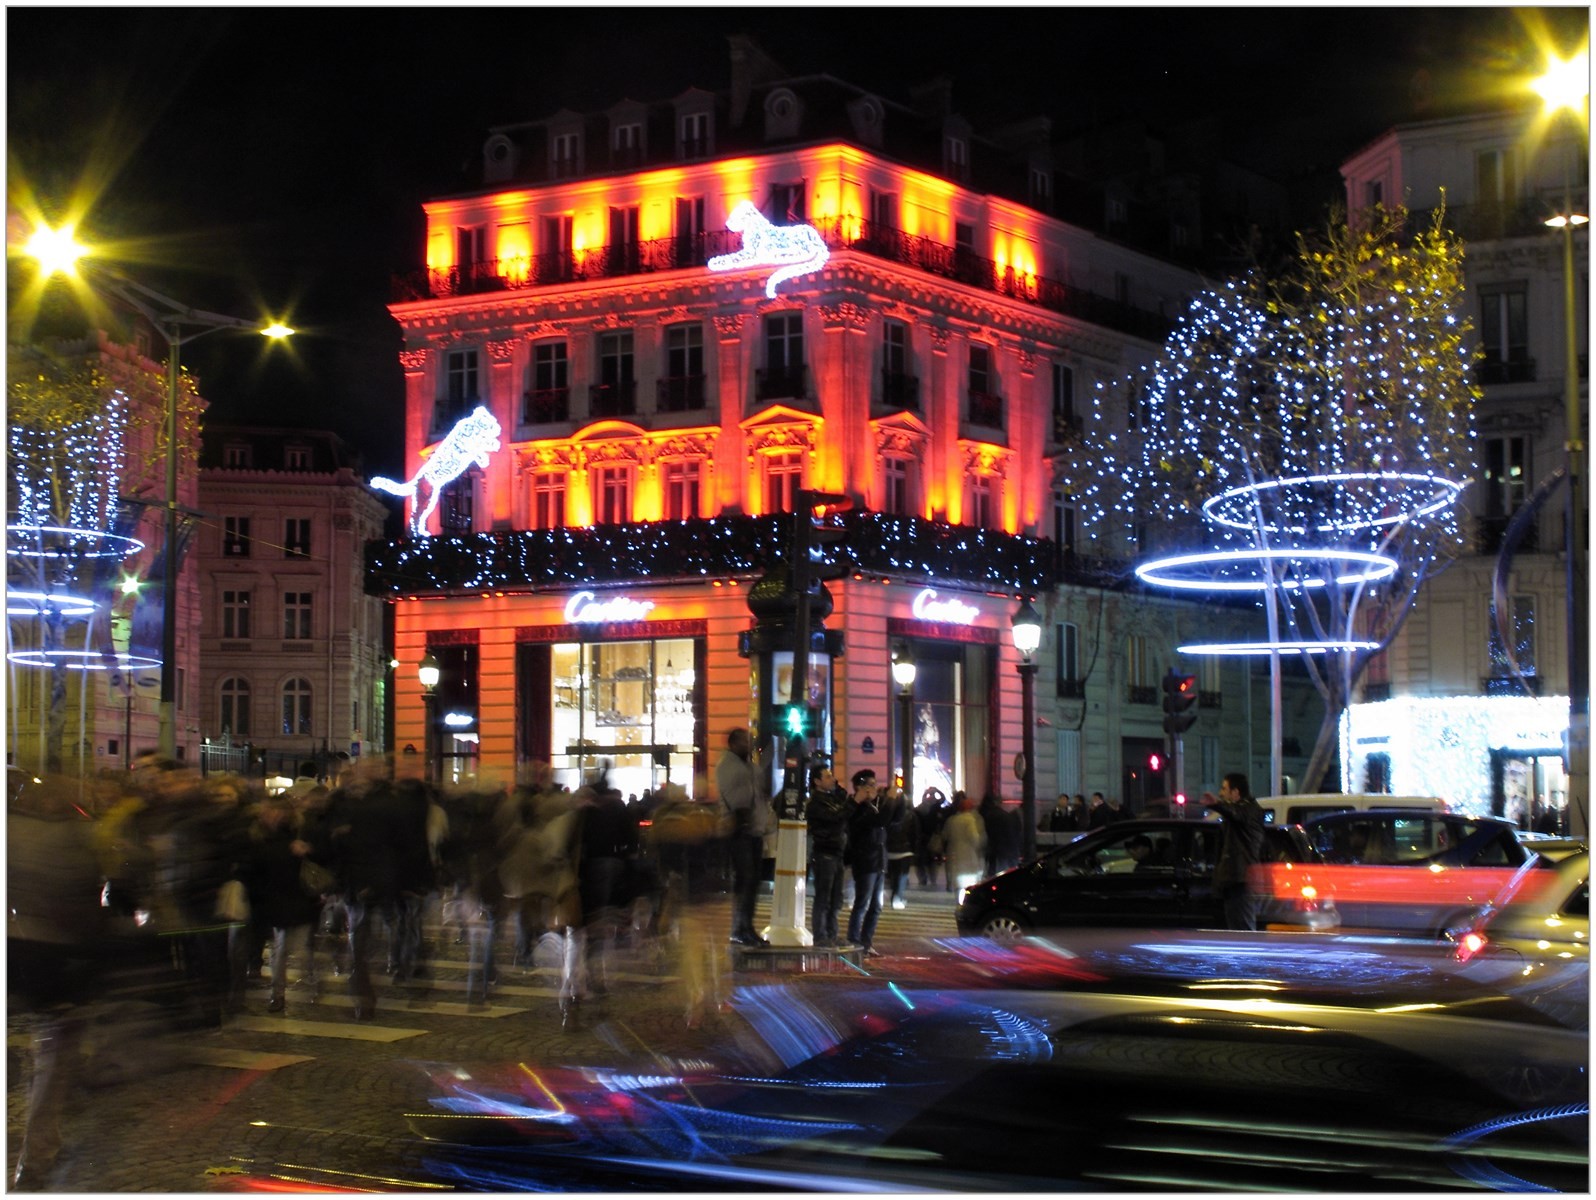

left=1341, top=109, right=1590, bottom=822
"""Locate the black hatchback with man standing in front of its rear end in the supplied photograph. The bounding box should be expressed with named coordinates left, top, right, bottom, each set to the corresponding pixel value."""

left=958, top=819, right=1339, bottom=938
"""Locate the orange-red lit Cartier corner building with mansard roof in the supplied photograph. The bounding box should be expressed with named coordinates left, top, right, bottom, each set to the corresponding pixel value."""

left=367, top=40, right=1270, bottom=798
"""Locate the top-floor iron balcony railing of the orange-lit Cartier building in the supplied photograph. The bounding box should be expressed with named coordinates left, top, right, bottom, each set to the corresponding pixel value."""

left=393, top=217, right=1173, bottom=341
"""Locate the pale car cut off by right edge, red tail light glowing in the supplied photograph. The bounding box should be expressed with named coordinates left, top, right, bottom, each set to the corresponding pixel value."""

left=1448, top=851, right=1591, bottom=970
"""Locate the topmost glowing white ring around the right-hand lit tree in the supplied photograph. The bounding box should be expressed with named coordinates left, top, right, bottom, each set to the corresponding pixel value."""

left=1202, top=471, right=1464, bottom=533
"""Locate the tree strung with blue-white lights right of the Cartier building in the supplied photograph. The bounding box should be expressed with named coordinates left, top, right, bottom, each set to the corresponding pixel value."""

left=1082, top=206, right=1479, bottom=791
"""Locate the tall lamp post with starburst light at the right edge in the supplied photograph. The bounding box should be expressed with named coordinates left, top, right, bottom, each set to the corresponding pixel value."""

left=1535, top=51, right=1590, bottom=836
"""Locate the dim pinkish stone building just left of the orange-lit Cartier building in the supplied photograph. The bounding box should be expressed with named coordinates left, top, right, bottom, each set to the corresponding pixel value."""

left=192, top=424, right=388, bottom=779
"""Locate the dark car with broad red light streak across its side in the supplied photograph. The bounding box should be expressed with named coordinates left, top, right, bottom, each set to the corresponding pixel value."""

left=1302, top=809, right=1539, bottom=938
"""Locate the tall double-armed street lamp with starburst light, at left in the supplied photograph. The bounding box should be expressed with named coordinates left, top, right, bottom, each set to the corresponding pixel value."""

left=26, top=227, right=294, bottom=758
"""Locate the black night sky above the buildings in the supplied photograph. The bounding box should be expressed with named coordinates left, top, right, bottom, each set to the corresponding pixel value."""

left=6, top=5, right=1590, bottom=474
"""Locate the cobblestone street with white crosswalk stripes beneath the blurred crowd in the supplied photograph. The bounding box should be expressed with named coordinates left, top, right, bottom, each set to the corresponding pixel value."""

left=6, top=892, right=954, bottom=1192
